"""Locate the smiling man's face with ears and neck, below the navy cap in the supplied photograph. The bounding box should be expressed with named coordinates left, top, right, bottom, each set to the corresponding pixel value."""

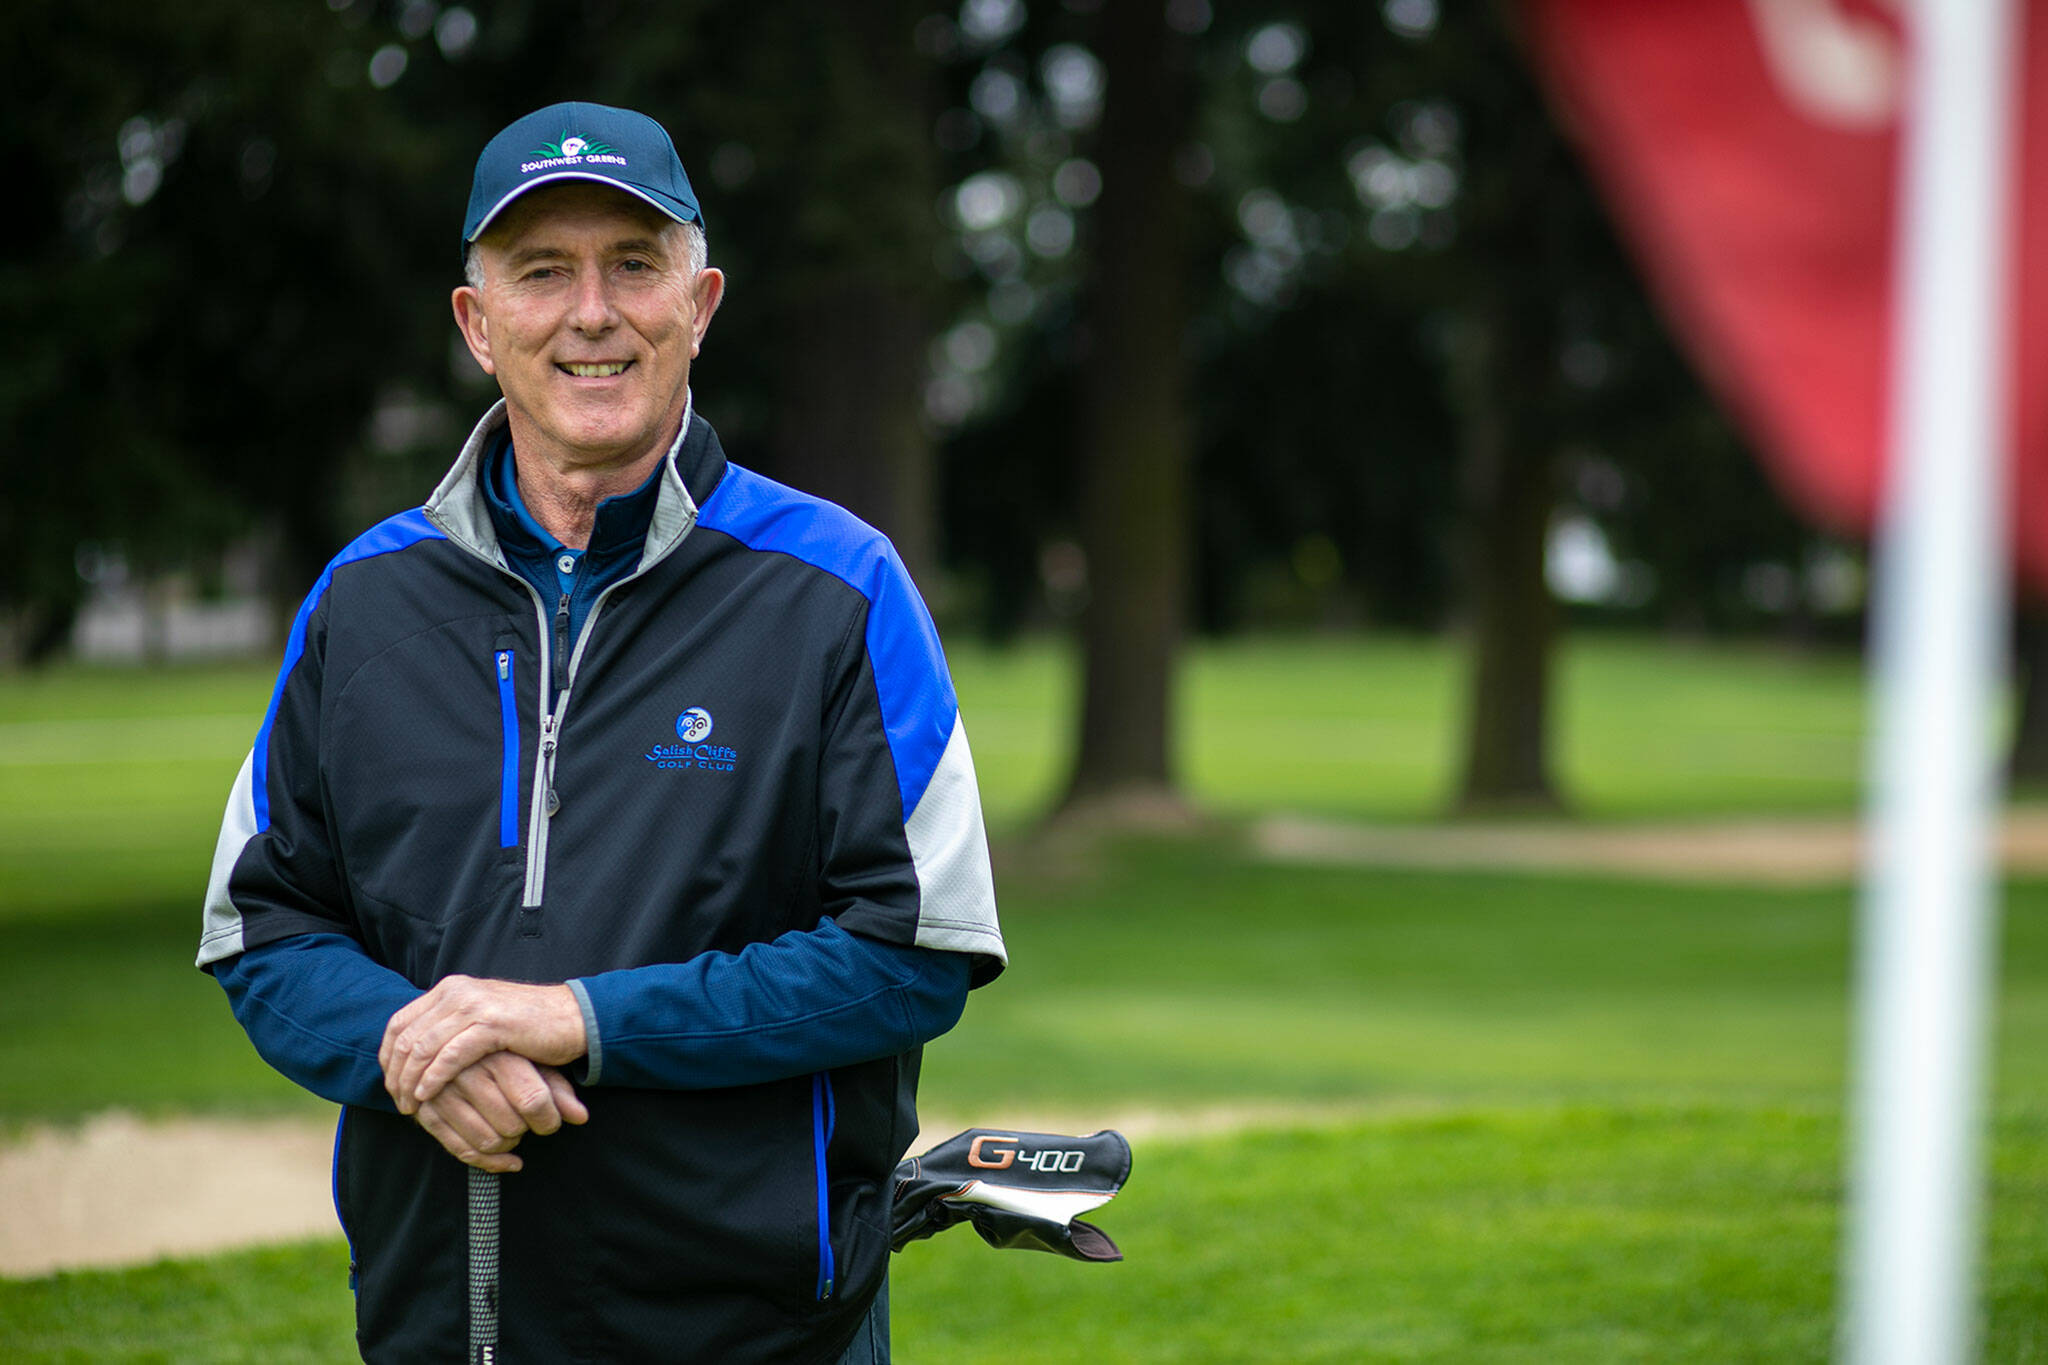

left=455, top=182, right=725, bottom=471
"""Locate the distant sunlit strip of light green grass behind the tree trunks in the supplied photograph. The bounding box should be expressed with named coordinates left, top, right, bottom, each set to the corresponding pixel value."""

left=0, top=636, right=1862, bottom=919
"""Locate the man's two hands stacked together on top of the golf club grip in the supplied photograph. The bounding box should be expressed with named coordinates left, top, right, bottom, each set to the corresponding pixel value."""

left=377, top=976, right=590, bottom=1171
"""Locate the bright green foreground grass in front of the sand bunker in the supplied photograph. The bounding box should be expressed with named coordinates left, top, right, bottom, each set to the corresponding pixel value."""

left=12, top=1105, right=2048, bottom=1365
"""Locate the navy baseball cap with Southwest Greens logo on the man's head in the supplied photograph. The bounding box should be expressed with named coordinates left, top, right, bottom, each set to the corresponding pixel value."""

left=463, top=102, right=705, bottom=250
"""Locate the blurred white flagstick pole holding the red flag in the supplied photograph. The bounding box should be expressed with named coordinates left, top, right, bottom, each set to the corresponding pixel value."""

left=1843, top=0, right=2019, bottom=1365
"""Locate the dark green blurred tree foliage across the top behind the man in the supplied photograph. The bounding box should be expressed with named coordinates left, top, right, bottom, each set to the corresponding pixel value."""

left=12, top=0, right=1843, bottom=663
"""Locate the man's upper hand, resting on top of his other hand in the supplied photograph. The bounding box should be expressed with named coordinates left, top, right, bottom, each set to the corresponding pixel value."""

left=377, top=976, right=588, bottom=1113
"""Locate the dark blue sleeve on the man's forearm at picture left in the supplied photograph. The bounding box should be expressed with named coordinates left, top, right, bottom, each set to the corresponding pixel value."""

left=213, top=933, right=422, bottom=1111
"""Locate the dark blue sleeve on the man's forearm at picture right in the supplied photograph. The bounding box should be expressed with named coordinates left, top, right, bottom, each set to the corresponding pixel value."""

left=569, top=919, right=971, bottom=1091
